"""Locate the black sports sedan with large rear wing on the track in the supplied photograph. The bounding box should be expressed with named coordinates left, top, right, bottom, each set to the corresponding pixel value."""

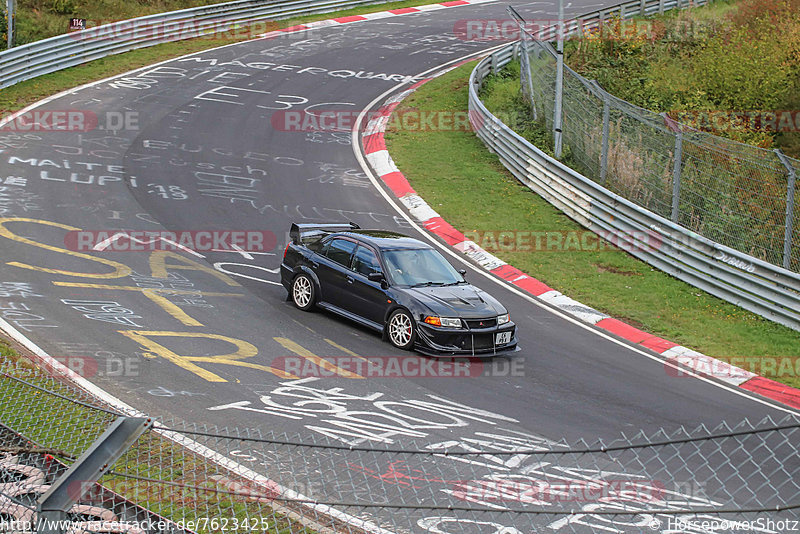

left=281, top=223, right=517, bottom=356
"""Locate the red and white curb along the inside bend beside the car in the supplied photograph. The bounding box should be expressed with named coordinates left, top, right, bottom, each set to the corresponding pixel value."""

left=362, top=66, right=800, bottom=408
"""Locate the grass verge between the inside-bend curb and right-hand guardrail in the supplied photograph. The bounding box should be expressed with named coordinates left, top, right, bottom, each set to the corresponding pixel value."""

left=386, top=63, right=800, bottom=387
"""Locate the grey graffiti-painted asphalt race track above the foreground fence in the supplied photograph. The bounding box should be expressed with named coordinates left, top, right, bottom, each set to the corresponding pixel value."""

left=0, top=2, right=793, bottom=532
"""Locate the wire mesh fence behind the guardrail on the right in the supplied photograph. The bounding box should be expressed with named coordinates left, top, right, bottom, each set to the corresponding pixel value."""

left=520, top=21, right=800, bottom=272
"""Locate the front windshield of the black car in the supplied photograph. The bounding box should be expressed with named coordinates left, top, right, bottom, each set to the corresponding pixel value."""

left=383, top=248, right=464, bottom=286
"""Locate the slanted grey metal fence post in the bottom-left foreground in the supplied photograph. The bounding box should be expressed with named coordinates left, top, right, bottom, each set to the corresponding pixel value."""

left=36, top=417, right=153, bottom=534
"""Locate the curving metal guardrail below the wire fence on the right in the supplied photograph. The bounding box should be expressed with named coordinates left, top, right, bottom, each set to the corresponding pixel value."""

left=469, top=0, right=800, bottom=330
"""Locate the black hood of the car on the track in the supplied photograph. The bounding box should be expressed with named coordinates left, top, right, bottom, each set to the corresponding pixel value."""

left=405, top=284, right=506, bottom=318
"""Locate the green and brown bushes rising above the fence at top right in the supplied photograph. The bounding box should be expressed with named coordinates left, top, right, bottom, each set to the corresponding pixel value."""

left=566, top=0, right=800, bottom=157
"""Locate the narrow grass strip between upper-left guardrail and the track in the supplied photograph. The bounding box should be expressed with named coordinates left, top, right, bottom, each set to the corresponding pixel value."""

left=0, top=0, right=450, bottom=112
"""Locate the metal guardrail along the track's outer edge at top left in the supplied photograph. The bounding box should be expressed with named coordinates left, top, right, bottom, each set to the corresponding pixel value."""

left=0, top=0, right=385, bottom=88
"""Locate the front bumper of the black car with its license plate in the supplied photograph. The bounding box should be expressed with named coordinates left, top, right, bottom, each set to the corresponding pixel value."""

left=415, top=322, right=517, bottom=356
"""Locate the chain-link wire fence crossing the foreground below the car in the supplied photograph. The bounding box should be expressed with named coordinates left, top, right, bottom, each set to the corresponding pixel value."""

left=0, top=361, right=800, bottom=534
